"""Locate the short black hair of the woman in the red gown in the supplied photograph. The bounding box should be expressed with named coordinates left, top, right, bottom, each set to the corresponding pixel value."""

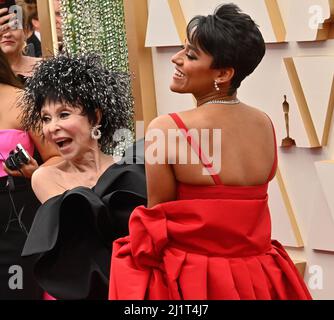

left=187, top=4, right=266, bottom=94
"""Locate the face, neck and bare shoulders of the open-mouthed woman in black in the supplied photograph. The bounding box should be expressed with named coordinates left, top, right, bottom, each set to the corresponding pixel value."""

left=32, top=102, right=114, bottom=203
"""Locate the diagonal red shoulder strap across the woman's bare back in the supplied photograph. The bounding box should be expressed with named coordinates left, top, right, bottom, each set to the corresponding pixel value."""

left=169, top=113, right=222, bottom=185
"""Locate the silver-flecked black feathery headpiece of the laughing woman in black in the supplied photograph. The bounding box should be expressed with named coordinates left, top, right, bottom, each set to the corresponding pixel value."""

left=20, top=54, right=133, bottom=152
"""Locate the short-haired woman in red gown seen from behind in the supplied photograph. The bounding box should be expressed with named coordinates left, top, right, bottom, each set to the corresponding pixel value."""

left=109, top=4, right=311, bottom=300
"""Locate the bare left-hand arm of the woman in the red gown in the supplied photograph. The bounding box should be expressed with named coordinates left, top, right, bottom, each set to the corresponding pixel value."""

left=145, top=116, right=176, bottom=208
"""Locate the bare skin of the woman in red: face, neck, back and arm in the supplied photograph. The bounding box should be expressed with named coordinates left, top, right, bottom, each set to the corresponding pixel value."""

left=145, top=42, right=275, bottom=207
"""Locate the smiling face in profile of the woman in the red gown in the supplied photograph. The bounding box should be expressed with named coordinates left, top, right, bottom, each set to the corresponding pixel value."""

left=170, top=41, right=219, bottom=99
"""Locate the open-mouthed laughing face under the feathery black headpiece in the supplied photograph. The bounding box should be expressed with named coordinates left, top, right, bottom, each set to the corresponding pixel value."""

left=41, top=102, right=97, bottom=160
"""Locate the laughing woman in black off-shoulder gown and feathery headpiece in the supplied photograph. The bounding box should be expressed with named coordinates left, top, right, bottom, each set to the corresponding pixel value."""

left=22, top=54, right=146, bottom=299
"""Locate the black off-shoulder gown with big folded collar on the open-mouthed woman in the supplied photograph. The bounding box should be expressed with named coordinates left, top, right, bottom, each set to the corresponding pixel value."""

left=22, top=141, right=146, bottom=300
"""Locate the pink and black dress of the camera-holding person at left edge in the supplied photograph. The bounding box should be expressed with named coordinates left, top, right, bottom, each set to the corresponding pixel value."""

left=0, top=129, right=43, bottom=300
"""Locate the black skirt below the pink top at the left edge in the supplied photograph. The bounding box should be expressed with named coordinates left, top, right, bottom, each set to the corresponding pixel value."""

left=0, top=176, right=43, bottom=300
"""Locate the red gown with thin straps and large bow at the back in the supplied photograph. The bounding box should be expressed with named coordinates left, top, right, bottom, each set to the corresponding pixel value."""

left=109, top=114, right=311, bottom=300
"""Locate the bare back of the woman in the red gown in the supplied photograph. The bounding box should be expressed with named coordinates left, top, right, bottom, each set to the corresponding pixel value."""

left=170, top=104, right=275, bottom=186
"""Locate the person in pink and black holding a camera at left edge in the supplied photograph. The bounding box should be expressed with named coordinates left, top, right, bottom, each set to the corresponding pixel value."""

left=0, top=49, right=57, bottom=300
